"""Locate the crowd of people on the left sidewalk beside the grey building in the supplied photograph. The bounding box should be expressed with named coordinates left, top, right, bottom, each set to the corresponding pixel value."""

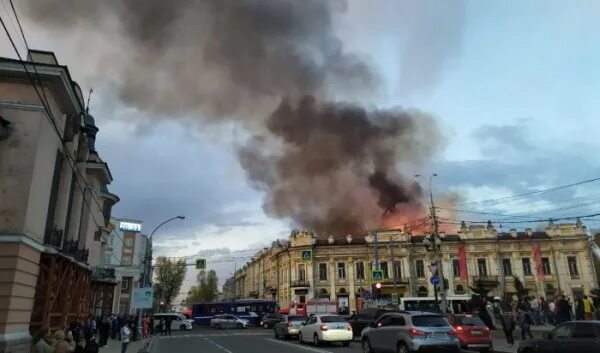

left=31, top=314, right=161, bottom=353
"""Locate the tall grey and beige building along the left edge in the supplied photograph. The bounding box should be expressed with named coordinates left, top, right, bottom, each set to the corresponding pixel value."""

left=0, top=50, right=119, bottom=352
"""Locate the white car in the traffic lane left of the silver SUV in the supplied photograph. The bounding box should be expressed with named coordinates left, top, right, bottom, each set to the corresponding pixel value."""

left=298, top=315, right=352, bottom=347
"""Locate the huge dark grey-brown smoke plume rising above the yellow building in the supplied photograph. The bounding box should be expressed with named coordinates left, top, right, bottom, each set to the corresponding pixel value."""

left=21, top=0, right=438, bottom=236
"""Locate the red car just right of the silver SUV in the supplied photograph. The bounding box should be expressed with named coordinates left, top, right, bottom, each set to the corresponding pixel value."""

left=448, top=314, right=492, bottom=352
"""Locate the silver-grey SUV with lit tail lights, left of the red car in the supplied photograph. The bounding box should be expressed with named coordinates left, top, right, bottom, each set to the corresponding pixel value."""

left=361, top=311, right=460, bottom=353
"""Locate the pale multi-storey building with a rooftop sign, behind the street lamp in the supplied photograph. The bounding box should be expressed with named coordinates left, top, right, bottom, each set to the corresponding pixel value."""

left=102, top=217, right=148, bottom=314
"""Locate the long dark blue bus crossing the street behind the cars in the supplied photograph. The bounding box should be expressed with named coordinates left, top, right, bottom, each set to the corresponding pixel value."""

left=192, top=299, right=277, bottom=326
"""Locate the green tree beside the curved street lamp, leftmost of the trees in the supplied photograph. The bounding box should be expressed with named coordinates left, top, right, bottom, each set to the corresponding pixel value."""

left=154, top=256, right=187, bottom=307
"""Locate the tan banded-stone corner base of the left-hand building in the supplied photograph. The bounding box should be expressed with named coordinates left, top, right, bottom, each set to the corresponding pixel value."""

left=0, top=236, right=42, bottom=353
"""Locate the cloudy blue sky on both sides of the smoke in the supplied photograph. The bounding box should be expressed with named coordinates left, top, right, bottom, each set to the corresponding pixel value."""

left=0, top=0, right=600, bottom=291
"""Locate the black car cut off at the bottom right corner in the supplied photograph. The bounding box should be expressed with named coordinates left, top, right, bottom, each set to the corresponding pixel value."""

left=517, top=320, right=600, bottom=353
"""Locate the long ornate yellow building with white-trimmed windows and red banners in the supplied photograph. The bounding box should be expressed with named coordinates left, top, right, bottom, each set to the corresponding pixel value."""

left=235, top=221, right=597, bottom=310
